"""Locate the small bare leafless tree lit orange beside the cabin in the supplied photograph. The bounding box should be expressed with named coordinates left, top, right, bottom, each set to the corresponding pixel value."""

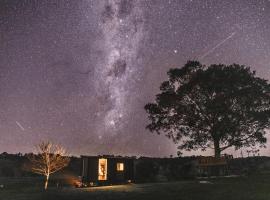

left=26, top=141, right=70, bottom=190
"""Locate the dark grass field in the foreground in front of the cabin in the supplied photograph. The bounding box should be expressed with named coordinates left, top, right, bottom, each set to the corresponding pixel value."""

left=0, top=174, right=270, bottom=200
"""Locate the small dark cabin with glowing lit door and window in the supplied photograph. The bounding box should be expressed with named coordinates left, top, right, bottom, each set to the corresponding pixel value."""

left=81, top=156, right=134, bottom=186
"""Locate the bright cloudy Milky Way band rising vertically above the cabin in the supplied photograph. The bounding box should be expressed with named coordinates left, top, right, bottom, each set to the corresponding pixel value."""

left=96, top=0, right=145, bottom=133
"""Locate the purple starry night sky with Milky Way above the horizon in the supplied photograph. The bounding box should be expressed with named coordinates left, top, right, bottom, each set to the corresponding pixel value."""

left=0, top=0, right=270, bottom=156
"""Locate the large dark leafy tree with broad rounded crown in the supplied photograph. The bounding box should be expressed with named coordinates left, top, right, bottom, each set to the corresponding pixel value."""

left=145, top=61, right=270, bottom=158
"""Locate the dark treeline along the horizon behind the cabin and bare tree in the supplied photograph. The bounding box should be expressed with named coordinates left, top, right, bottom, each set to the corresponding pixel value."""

left=0, top=152, right=270, bottom=182
